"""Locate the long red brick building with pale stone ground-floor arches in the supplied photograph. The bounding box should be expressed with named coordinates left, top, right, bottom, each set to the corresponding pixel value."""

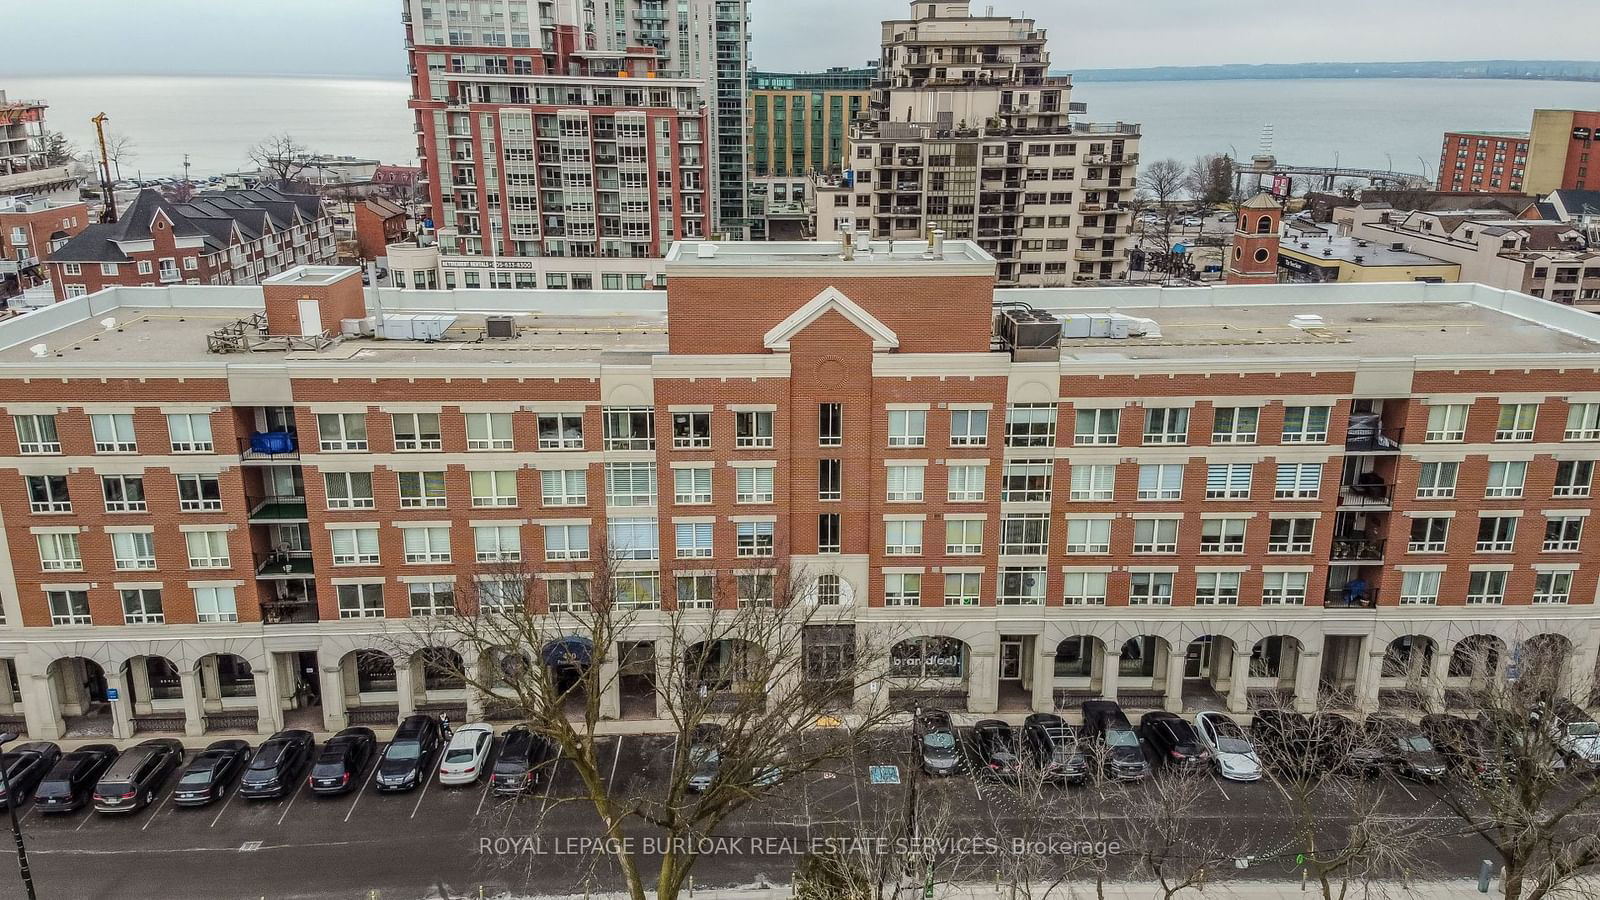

left=0, top=242, right=1600, bottom=737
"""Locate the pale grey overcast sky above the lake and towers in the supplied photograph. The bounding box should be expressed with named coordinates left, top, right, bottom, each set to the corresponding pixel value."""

left=0, top=0, right=1600, bottom=76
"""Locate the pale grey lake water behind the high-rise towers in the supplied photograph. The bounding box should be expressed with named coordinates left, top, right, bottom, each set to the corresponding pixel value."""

left=12, top=75, right=1600, bottom=176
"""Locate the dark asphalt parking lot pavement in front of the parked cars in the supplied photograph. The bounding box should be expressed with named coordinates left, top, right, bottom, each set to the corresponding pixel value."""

left=9, top=735, right=1510, bottom=900
